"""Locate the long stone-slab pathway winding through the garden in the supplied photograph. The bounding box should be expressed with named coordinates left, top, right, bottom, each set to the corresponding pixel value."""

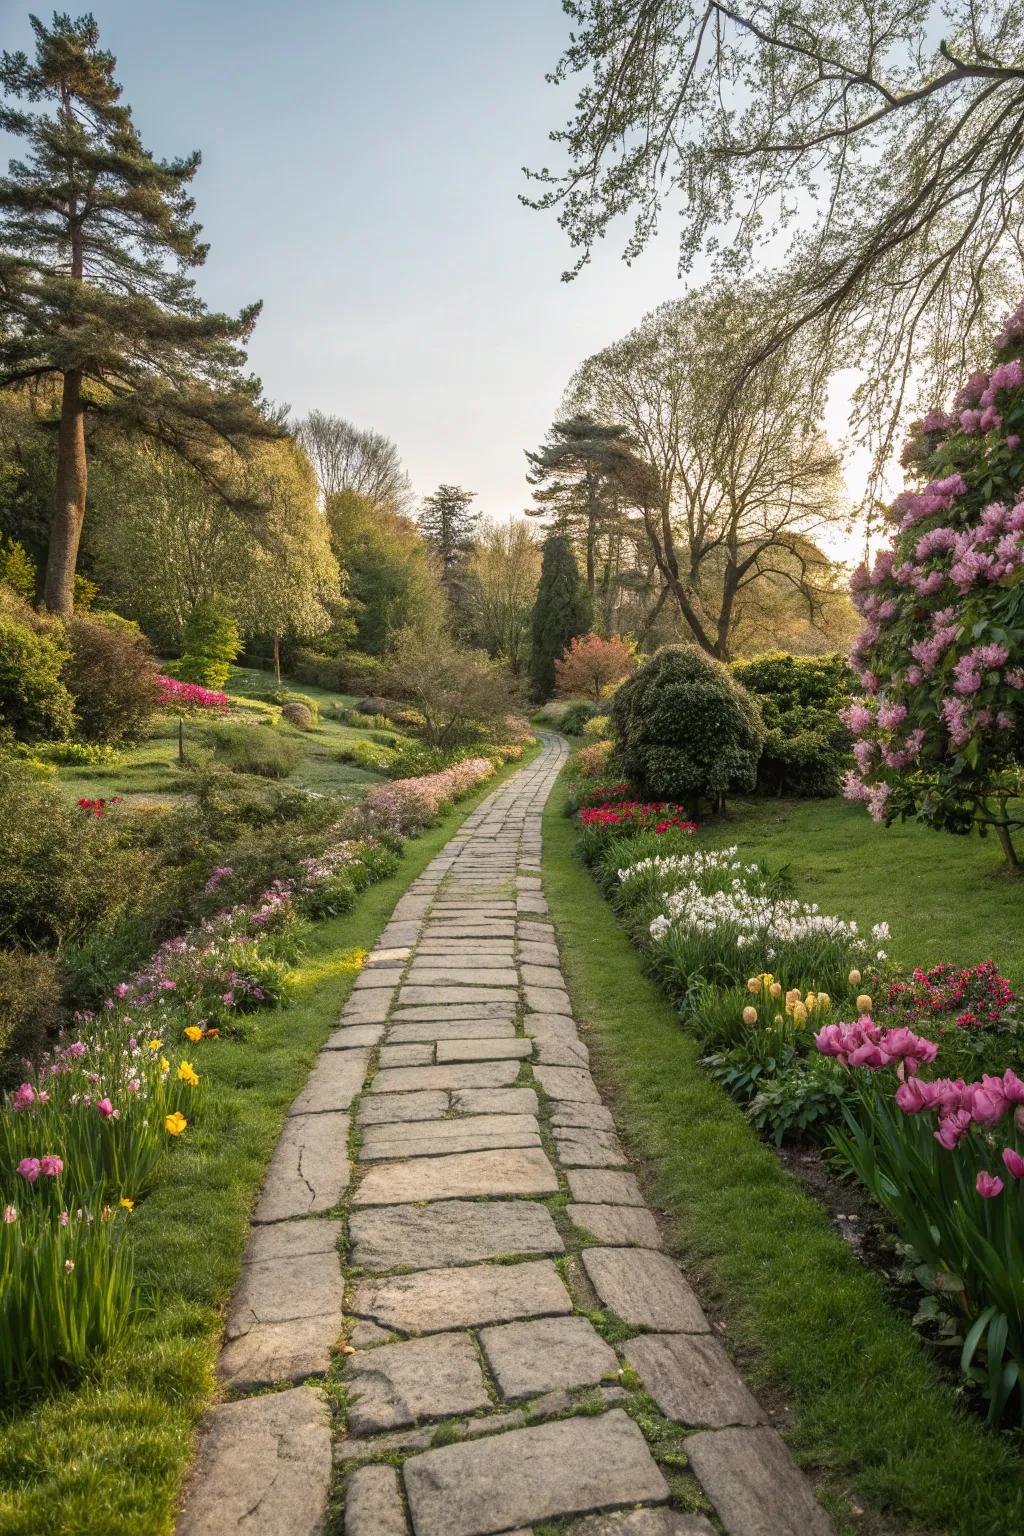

left=178, top=739, right=832, bottom=1536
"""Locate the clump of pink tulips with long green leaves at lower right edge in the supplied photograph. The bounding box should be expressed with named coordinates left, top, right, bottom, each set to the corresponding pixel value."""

left=815, top=1014, right=1024, bottom=1424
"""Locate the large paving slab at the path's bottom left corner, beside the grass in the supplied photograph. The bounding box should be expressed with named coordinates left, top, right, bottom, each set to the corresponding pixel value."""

left=178, top=1387, right=332, bottom=1536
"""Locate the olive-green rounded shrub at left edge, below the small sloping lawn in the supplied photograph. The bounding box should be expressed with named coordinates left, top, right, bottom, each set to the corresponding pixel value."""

left=0, top=757, right=149, bottom=949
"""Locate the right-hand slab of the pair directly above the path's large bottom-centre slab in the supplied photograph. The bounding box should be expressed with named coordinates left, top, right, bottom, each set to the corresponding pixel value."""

left=481, top=1316, right=619, bottom=1402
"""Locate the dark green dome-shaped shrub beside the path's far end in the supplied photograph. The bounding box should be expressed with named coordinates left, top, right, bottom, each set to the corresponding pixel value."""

left=611, top=645, right=765, bottom=811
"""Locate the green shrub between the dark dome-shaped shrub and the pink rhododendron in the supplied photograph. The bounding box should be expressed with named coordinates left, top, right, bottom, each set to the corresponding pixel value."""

left=732, top=651, right=852, bottom=799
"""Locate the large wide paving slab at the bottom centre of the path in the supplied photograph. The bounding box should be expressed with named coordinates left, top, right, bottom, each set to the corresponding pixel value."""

left=402, top=1409, right=668, bottom=1536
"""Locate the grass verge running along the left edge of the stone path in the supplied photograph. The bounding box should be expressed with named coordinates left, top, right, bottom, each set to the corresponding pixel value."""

left=0, top=746, right=540, bottom=1536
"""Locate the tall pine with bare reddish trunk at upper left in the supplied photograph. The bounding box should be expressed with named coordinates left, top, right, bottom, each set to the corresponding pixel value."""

left=0, top=14, right=282, bottom=613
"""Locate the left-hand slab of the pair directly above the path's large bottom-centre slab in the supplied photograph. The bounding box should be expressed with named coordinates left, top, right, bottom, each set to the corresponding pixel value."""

left=342, top=1333, right=491, bottom=1435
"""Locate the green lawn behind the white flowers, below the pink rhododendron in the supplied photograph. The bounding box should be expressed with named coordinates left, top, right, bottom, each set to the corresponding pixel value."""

left=700, top=799, right=1024, bottom=986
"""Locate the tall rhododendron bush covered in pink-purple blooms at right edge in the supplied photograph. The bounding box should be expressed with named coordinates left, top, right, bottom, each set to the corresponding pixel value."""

left=846, top=306, right=1024, bottom=868
